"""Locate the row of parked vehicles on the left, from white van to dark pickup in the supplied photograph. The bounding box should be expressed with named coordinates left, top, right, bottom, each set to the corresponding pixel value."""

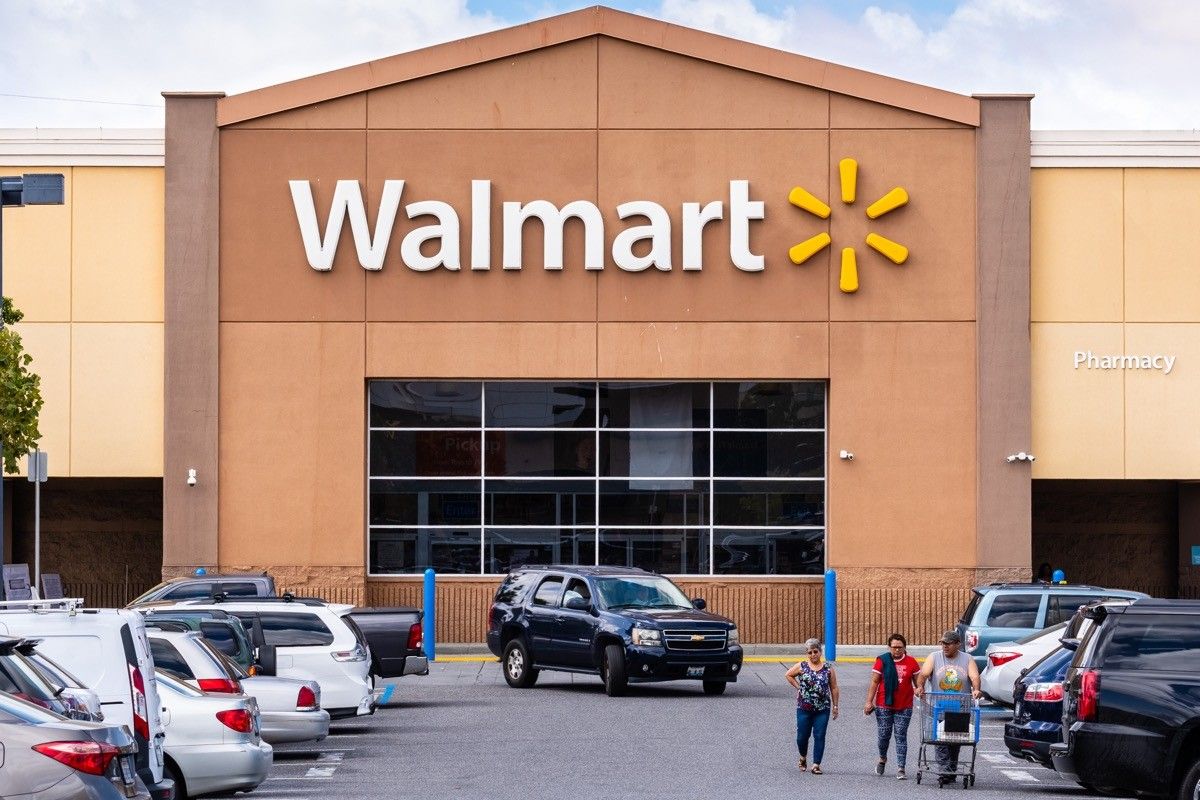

left=0, top=576, right=427, bottom=800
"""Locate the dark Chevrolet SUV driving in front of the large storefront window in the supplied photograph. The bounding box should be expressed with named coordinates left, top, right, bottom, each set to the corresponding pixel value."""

left=487, top=566, right=742, bottom=697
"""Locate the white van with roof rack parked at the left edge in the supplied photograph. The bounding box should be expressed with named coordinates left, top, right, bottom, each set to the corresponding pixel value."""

left=0, top=600, right=175, bottom=800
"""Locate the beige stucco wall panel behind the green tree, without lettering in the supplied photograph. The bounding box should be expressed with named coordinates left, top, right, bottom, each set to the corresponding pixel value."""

left=0, top=166, right=163, bottom=477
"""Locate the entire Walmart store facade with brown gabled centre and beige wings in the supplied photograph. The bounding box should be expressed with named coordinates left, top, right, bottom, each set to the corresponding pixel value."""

left=0, top=8, right=1200, bottom=642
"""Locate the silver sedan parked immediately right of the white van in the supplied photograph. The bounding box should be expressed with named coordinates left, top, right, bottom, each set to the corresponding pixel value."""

left=155, top=670, right=274, bottom=799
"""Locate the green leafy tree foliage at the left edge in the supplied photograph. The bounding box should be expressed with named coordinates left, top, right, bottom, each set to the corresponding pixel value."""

left=0, top=297, right=43, bottom=473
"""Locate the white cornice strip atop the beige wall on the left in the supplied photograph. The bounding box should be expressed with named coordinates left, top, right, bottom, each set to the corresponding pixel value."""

left=0, top=128, right=164, bottom=167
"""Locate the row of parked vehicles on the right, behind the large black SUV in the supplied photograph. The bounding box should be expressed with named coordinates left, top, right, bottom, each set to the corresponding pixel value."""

left=962, top=584, right=1200, bottom=800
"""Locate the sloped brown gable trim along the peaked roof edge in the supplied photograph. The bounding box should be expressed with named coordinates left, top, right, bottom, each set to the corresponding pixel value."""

left=217, top=6, right=979, bottom=126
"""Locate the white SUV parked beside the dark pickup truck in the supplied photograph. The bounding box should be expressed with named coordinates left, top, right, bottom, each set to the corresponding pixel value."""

left=162, top=595, right=374, bottom=718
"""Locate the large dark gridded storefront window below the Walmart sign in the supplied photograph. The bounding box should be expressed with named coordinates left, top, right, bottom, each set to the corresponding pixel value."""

left=367, top=380, right=826, bottom=575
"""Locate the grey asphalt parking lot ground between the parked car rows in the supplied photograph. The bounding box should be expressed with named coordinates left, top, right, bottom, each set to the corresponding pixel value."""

left=213, top=658, right=1094, bottom=800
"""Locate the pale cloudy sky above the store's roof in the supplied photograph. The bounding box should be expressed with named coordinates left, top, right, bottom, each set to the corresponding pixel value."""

left=0, top=0, right=1200, bottom=131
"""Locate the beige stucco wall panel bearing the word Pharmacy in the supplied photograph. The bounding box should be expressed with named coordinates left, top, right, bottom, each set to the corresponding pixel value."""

left=1032, top=168, right=1200, bottom=480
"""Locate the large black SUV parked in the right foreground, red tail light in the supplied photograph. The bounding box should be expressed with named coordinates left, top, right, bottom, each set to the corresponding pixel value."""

left=1050, top=600, right=1200, bottom=800
